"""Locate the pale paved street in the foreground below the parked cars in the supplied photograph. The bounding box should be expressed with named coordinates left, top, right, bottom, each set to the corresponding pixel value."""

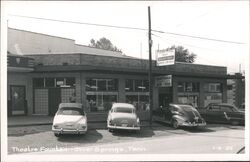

left=8, top=124, right=244, bottom=154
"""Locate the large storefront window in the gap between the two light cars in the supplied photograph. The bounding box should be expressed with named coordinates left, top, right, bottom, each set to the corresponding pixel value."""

left=86, top=78, right=118, bottom=112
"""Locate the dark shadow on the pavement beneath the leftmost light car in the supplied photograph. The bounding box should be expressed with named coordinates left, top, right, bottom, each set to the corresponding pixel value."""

left=57, top=130, right=103, bottom=144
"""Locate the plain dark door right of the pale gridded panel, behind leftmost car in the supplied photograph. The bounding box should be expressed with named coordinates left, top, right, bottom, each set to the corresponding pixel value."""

left=49, top=88, right=61, bottom=116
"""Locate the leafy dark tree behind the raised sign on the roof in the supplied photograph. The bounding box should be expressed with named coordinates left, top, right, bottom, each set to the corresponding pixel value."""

left=168, top=46, right=196, bottom=63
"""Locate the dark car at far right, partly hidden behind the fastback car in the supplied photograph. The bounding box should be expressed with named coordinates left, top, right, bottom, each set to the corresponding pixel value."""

left=198, top=103, right=245, bottom=125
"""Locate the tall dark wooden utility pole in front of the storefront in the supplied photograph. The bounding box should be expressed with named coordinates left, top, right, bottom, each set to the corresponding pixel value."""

left=148, top=6, right=153, bottom=127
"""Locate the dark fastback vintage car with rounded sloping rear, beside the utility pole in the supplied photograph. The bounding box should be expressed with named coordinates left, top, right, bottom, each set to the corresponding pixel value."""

left=153, top=104, right=206, bottom=129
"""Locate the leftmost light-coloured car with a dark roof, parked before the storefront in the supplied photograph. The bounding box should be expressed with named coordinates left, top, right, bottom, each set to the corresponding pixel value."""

left=52, top=103, right=88, bottom=137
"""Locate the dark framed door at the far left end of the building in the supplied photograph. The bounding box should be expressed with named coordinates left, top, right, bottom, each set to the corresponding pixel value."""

left=10, top=86, right=27, bottom=115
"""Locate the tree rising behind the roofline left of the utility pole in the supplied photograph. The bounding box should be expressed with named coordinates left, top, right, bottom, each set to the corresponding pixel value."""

left=89, top=37, right=122, bottom=52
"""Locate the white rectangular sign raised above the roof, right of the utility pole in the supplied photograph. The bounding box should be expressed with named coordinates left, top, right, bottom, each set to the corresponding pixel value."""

left=156, top=49, right=175, bottom=66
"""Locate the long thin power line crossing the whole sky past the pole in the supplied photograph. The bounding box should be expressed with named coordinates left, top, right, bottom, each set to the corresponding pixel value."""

left=9, top=14, right=245, bottom=44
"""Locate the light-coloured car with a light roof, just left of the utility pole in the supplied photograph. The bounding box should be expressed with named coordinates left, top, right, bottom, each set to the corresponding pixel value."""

left=107, top=103, right=140, bottom=131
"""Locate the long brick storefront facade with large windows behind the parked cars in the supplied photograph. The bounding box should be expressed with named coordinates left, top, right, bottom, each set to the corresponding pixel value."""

left=8, top=54, right=227, bottom=115
